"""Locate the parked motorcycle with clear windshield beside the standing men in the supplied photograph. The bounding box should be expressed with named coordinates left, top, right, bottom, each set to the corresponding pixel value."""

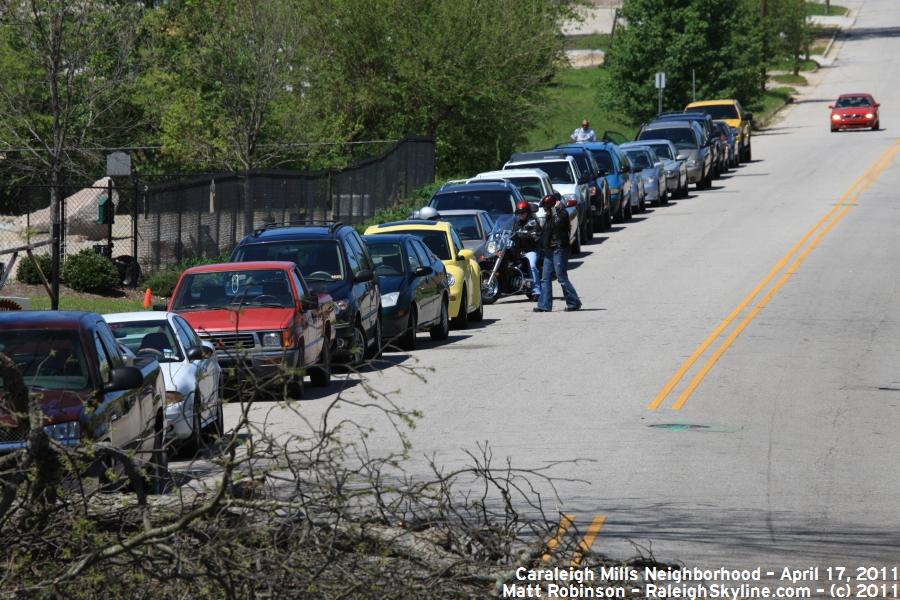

left=479, top=215, right=532, bottom=304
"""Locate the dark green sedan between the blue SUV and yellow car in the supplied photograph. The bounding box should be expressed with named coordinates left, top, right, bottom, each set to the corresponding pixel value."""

left=363, top=234, right=450, bottom=350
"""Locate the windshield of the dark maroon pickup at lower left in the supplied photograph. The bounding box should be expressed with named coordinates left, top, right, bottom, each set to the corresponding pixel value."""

left=0, top=329, right=90, bottom=391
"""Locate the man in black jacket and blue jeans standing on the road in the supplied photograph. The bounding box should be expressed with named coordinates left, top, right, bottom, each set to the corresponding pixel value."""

left=534, top=196, right=581, bottom=312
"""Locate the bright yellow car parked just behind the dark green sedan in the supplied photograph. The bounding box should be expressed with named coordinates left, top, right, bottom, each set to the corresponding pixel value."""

left=365, top=220, right=484, bottom=327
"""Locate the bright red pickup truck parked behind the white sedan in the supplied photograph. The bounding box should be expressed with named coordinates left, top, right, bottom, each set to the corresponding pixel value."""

left=168, top=261, right=335, bottom=398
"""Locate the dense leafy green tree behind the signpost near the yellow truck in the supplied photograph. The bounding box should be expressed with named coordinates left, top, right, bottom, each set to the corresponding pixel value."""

left=599, top=0, right=763, bottom=122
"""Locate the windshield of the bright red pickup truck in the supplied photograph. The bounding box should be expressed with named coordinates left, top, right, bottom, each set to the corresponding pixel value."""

left=172, top=269, right=294, bottom=310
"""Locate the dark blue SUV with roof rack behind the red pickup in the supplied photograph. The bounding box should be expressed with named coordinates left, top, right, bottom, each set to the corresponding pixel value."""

left=231, top=222, right=382, bottom=365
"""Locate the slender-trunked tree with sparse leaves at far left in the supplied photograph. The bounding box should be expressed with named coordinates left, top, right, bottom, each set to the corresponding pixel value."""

left=0, top=0, right=140, bottom=308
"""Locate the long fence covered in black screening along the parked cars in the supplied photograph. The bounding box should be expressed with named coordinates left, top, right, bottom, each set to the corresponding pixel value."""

left=136, top=137, right=435, bottom=273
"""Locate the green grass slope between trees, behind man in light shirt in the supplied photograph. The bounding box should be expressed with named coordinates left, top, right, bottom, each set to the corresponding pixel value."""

left=518, top=67, right=637, bottom=150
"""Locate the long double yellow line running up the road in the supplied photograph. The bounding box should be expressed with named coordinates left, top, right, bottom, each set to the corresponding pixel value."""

left=647, top=141, right=900, bottom=410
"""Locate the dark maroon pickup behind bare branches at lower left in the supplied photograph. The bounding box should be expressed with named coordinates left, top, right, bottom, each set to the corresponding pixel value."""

left=0, top=311, right=167, bottom=491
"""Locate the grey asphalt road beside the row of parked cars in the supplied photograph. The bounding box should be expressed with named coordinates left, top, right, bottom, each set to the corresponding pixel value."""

left=216, top=0, right=900, bottom=584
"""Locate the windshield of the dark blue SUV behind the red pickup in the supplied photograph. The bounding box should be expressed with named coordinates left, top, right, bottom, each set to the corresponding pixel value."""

left=234, top=240, right=346, bottom=281
